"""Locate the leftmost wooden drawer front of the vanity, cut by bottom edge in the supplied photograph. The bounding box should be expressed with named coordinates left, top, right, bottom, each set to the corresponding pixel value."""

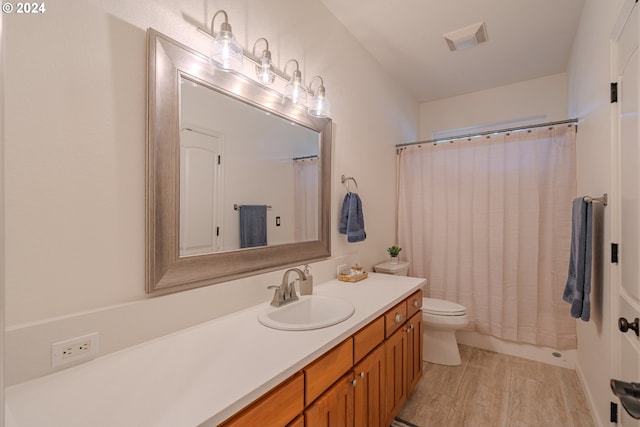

left=221, top=372, right=304, bottom=427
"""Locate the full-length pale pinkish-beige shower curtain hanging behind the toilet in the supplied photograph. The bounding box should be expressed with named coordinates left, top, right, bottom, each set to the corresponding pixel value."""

left=398, top=125, right=576, bottom=349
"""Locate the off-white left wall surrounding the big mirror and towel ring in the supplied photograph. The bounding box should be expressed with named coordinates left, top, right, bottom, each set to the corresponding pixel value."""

left=4, top=0, right=418, bottom=385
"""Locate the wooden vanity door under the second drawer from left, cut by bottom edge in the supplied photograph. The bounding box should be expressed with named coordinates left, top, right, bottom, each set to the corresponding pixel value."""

left=304, top=372, right=354, bottom=427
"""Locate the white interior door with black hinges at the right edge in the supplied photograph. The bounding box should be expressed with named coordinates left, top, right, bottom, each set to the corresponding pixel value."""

left=610, top=0, right=640, bottom=427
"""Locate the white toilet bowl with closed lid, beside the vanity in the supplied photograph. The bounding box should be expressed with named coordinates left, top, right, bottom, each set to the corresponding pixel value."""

left=422, top=297, right=469, bottom=366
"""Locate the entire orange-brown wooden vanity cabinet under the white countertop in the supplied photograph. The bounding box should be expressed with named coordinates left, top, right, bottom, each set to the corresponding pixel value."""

left=222, top=291, right=422, bottom=427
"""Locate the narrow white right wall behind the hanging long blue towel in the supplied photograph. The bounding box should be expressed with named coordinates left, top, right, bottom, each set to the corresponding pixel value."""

left=568, top=0, right=624, bottom=425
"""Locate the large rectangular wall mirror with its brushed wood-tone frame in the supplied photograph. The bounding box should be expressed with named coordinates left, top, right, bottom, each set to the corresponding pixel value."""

left=146, top=29, right=332, bottom=294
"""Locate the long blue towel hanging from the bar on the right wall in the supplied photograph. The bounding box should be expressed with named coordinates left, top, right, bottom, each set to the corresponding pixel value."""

left=562, top=197, right=593, bottom=322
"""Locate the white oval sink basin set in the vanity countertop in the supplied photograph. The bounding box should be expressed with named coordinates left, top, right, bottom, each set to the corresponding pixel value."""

left=258, top=295, right=355, bottom=331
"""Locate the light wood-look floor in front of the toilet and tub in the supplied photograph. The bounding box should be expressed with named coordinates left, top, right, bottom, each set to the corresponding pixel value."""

left=398, top=345, right=595, bottom=427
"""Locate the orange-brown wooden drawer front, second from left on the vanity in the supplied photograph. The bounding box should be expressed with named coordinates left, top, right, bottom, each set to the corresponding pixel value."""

left=304, top=337, right=353, bottom=406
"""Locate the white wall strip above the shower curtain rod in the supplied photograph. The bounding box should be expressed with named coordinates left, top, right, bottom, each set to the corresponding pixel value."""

left=420, top=73, right=572, bottom=140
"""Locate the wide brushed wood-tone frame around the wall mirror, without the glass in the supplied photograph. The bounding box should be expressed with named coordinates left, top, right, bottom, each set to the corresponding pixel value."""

left=145, top=29, right=332, bottom=294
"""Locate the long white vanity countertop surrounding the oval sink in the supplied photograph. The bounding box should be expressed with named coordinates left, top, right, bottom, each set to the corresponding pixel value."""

left=5, top=273, right=424, bottom=427
